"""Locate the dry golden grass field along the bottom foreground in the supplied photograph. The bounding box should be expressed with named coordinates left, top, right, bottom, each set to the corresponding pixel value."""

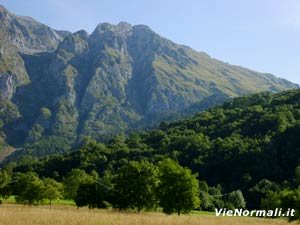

left=0, top=204, right=295, bottom=225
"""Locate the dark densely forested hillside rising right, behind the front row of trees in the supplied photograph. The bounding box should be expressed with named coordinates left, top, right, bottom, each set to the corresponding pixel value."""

left=10, top=89, right=300, bottom=210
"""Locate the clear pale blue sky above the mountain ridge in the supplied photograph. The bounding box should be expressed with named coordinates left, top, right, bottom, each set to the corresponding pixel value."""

left=0, top=0, right=300, bottom=84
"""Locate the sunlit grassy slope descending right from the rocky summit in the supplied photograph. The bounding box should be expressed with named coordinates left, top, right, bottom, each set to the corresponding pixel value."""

left=153, top=45, right=297, bottom=101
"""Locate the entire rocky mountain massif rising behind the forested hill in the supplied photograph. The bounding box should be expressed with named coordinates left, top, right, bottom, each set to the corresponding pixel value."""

left=0, top=4, right=298, bottom=156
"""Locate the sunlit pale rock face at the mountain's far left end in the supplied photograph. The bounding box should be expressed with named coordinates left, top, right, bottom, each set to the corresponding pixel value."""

left=0, top=5, right=70, bottom=102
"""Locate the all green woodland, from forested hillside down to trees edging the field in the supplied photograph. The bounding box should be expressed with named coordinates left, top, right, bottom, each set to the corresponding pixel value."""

left=0, top=90, right=300, bottom=218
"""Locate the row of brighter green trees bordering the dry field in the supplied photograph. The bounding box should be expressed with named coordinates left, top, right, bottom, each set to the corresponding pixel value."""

left=0, top=159, right=246, bottom=215
